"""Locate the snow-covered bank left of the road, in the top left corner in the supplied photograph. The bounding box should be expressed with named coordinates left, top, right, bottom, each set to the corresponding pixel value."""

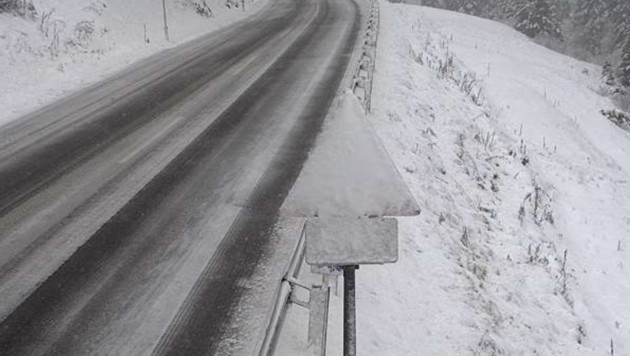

left=0, top=0, right=267, bottom=125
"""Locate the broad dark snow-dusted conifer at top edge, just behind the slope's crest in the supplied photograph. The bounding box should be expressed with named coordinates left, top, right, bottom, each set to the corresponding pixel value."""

left=514, top=0, right=562, bottom=40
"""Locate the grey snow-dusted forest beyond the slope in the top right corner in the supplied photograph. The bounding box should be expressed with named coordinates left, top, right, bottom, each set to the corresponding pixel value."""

left=422, top=0, right=630, bottom=117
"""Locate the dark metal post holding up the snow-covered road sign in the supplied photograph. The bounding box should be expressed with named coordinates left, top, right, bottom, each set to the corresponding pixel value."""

left=343, top=266, right=357, bottom=356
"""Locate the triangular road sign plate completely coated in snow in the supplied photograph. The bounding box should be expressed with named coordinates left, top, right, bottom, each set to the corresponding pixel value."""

left=283, top=91, right=418, bottom=217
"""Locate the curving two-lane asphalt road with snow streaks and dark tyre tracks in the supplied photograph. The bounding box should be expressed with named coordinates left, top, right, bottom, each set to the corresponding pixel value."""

left=0, top=0, right=359, bottom=355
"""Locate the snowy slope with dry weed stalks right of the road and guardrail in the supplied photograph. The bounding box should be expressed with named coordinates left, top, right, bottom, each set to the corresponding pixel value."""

left=357, top=2, right=630, bottom=355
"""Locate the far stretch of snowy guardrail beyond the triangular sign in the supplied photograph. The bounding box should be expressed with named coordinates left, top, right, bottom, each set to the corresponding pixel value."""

left=351, top=0, right=379, bottom=112
